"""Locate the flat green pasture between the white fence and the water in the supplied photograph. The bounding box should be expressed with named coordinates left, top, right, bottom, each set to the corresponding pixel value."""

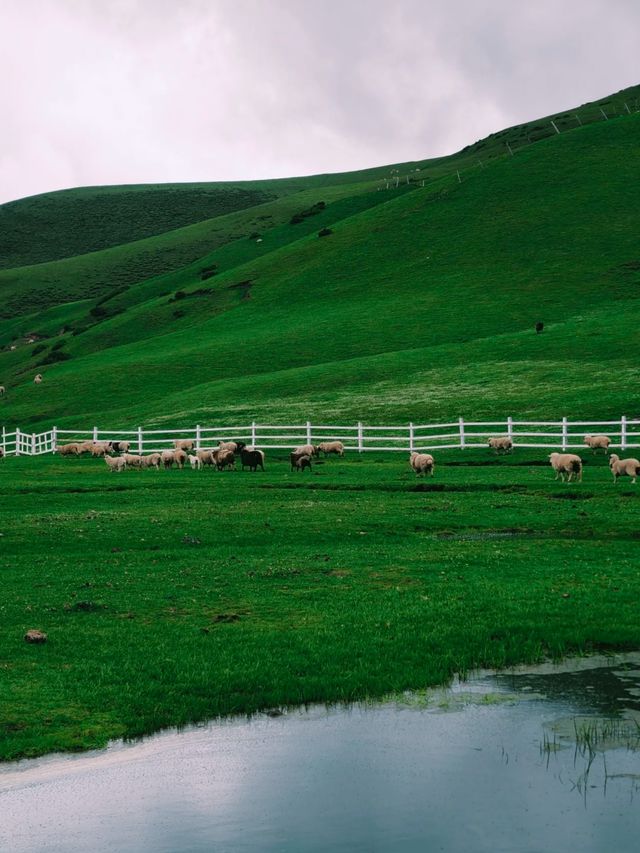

left=0, top=451, right=640, bottom=759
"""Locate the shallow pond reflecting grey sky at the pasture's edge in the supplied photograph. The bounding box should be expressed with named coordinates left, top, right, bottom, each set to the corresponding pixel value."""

left=0, top=654, right=640, bottom=853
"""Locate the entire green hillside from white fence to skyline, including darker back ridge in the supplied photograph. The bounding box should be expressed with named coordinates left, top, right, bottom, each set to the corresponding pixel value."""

left=0, top=87, right=640, bottom=429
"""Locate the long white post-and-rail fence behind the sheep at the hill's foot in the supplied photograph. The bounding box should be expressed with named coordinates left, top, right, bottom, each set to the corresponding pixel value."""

left=1, top=416, right=640, bottom=456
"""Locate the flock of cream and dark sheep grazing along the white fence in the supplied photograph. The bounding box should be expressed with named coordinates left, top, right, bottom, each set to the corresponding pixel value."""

left=46, top=435, right=640, bottom=483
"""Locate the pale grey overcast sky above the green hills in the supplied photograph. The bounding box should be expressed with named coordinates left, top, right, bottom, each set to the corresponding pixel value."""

left=0, top=0, right=640, bottom=202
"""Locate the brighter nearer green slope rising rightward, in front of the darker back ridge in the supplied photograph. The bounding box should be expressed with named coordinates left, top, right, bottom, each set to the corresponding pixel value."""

left=1, top=115, right=640, bottom=427
